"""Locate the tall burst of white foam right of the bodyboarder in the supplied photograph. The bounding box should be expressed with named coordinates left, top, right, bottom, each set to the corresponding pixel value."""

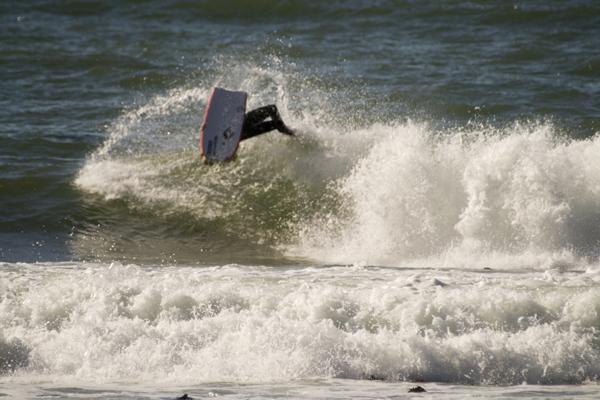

left=296, top=123, right=600, bottom=264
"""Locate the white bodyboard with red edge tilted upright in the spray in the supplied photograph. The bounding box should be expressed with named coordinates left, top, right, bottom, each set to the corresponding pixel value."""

left=200, top=87, right=248, bottom=162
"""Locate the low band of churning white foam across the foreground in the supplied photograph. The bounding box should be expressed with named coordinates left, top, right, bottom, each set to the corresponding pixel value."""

left=0, top=264, right=600, bottom=385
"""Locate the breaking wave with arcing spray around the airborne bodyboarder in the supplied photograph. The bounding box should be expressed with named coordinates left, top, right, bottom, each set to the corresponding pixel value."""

left=76, top=59, right=600, bottom=265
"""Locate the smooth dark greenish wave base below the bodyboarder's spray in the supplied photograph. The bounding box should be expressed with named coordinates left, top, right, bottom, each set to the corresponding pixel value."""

left=68, top=192, right=304, bottom=265
